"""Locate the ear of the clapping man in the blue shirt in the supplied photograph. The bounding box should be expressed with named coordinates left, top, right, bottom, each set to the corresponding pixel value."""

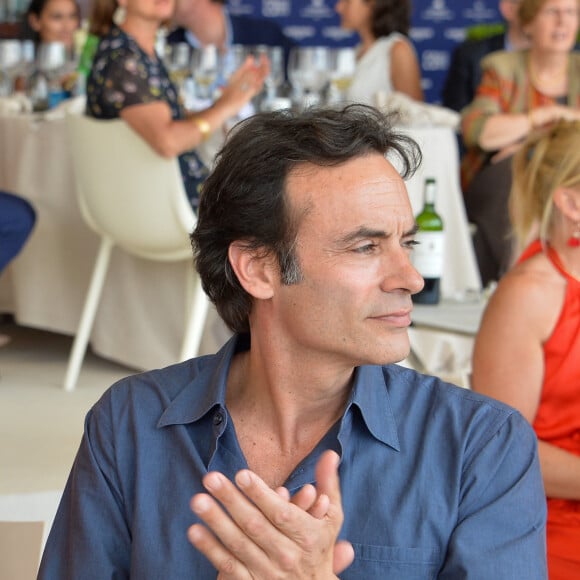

left=228, top=241, right=279, bottom=300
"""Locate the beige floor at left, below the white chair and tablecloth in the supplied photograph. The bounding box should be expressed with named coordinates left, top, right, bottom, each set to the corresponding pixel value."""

left=0, top=324, right=133, bottom=495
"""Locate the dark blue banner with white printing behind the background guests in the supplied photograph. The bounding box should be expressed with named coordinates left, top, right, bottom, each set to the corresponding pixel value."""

left=228, top=0, right=501, bottom=103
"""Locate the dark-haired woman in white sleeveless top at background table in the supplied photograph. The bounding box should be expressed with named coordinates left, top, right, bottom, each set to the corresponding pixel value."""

left=336, top=0, right=424, bottom=105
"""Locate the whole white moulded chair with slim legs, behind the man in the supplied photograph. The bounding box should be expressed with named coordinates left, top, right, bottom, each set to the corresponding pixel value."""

left=64, top=115, right=209, bottom=391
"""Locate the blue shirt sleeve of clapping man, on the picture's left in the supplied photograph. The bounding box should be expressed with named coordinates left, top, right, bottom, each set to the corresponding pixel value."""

left=38, top=399, right=131, bottom=580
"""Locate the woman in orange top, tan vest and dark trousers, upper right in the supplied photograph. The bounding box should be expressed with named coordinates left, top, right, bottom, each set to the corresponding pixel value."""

left=461, top=0, right=580, bottom=285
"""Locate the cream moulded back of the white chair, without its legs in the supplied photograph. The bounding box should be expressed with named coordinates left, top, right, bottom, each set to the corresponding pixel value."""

left=68, top=115, right=196, bottom=261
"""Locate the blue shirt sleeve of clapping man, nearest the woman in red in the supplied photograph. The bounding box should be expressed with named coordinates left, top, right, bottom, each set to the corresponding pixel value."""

left=438, top=412, right=548, bottom=580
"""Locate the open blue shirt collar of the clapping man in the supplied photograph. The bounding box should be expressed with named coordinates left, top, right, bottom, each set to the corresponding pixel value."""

left=157, top=335, right=399, bottom=451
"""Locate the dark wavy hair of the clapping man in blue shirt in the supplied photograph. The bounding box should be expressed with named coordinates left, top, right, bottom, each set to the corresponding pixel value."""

left=191, top=104, right=421, bottom=332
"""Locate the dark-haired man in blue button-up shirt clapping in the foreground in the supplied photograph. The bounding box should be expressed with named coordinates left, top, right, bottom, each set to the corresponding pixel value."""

left=39, top=105, right=546, bottom=580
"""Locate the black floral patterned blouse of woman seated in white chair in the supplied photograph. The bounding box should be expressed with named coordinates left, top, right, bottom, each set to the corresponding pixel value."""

left=87, top=26, right=208, bottom=211
